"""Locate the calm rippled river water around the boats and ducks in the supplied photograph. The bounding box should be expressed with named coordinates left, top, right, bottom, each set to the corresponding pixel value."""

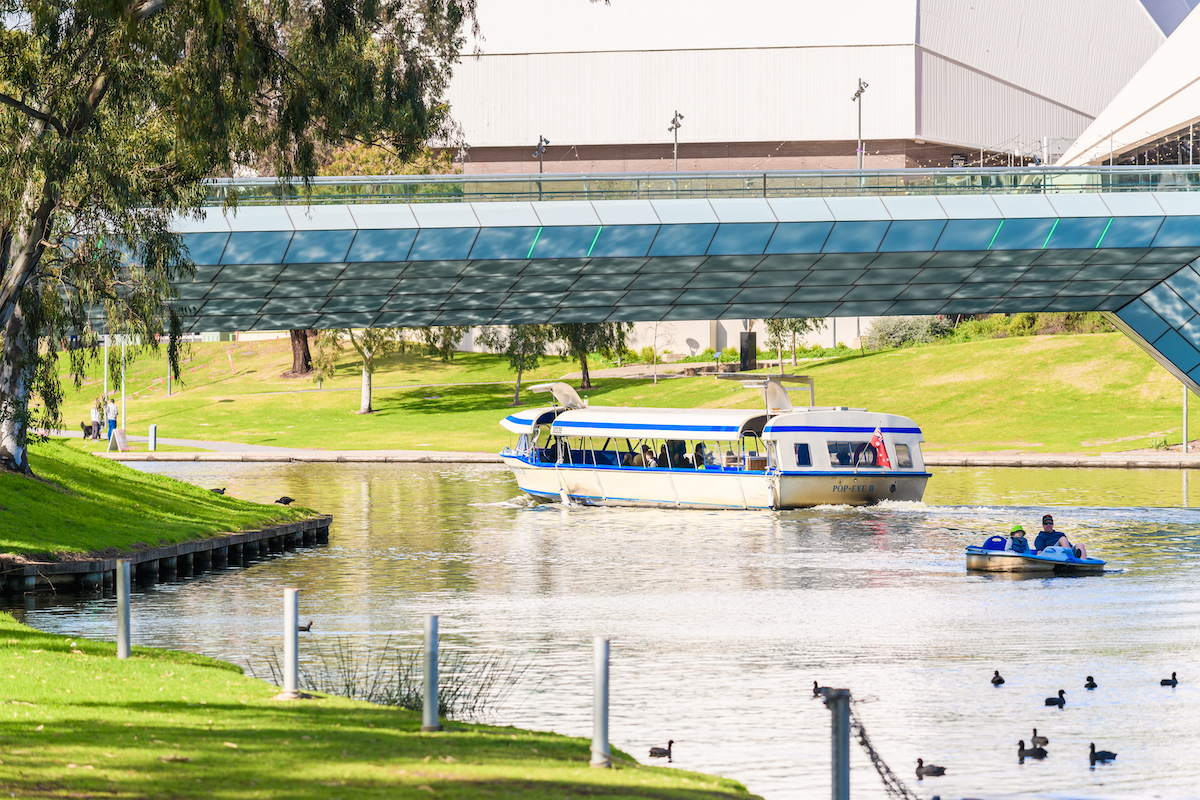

left=18, top=464, right=1200, bottom=799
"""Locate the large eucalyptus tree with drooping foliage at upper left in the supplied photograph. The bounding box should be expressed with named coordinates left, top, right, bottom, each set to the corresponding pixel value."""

left=0, top=0, right=475, bottom=471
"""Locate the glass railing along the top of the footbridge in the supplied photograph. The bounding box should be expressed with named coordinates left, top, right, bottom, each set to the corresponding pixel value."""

left=208, top=166, right=1200, bottom=205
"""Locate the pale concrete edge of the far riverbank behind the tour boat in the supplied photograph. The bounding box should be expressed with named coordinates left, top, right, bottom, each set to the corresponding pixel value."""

left=95, top=449, right=1200, bottom=469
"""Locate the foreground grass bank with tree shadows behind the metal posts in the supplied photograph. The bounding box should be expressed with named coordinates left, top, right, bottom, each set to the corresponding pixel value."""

left=0, top=614, right=750, bottom=800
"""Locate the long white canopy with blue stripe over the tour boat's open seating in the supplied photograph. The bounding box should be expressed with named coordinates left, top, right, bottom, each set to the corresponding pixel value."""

left=540, top=407, right=767, bottom=441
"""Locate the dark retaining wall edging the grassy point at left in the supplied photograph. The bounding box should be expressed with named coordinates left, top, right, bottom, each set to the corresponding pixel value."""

left=0, top=515, right=334, bottom=594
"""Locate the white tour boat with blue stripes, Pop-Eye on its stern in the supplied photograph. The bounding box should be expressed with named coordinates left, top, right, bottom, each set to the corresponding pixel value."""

left=500, top=374, right=930, bottom=509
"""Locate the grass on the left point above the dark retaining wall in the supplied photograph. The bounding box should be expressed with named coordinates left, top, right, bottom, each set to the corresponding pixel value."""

left=0, top=441, right=313, bottom=561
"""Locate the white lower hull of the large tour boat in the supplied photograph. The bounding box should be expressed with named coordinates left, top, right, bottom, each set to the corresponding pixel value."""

left=504, top=456, right=929, bottom=509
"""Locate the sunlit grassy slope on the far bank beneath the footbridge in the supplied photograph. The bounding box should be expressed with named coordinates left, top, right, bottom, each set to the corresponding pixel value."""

left=51, top=333, right=1200, bottom=452
